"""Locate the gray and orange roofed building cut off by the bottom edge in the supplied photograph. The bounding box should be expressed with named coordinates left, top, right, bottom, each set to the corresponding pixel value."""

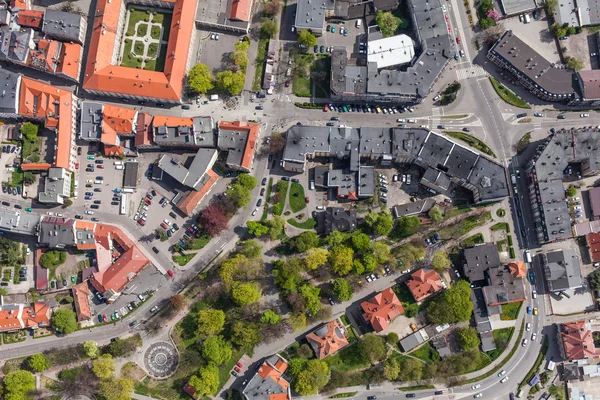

left=242, top=354, right=292, bottom=400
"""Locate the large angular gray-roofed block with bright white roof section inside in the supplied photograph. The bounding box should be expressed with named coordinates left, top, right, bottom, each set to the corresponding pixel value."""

left=330, top=0, right=456, bottom=105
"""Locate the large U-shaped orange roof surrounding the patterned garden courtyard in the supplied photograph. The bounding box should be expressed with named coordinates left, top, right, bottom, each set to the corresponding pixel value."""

left=83, top=0, right=197, bottom=102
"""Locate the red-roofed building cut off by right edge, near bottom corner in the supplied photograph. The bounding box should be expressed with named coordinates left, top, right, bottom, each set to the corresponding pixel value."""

left=557, top=319, right=600, bottom=361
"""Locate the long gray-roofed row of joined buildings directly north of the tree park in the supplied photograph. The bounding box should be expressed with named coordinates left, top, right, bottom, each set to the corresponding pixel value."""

left=283, top=125, right=508, bottom=203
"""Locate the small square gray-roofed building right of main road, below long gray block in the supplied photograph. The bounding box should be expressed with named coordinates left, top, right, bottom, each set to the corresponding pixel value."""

left=542, top=249, right=583, bottom=292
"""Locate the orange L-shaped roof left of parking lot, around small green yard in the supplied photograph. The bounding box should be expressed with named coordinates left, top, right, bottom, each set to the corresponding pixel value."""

left=19, top=76, right=73, bottom=171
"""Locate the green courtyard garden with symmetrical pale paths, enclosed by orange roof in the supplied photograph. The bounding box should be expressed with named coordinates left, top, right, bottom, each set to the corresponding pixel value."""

left=119, top=7, right=172, bottom=71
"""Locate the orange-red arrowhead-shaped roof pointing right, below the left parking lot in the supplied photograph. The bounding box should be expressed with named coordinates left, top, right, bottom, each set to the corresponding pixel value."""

left=91, top=224, right=150, bottom=293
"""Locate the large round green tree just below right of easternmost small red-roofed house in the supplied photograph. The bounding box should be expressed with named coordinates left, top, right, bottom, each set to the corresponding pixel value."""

left=427, top=281, right=473, bottom=324
